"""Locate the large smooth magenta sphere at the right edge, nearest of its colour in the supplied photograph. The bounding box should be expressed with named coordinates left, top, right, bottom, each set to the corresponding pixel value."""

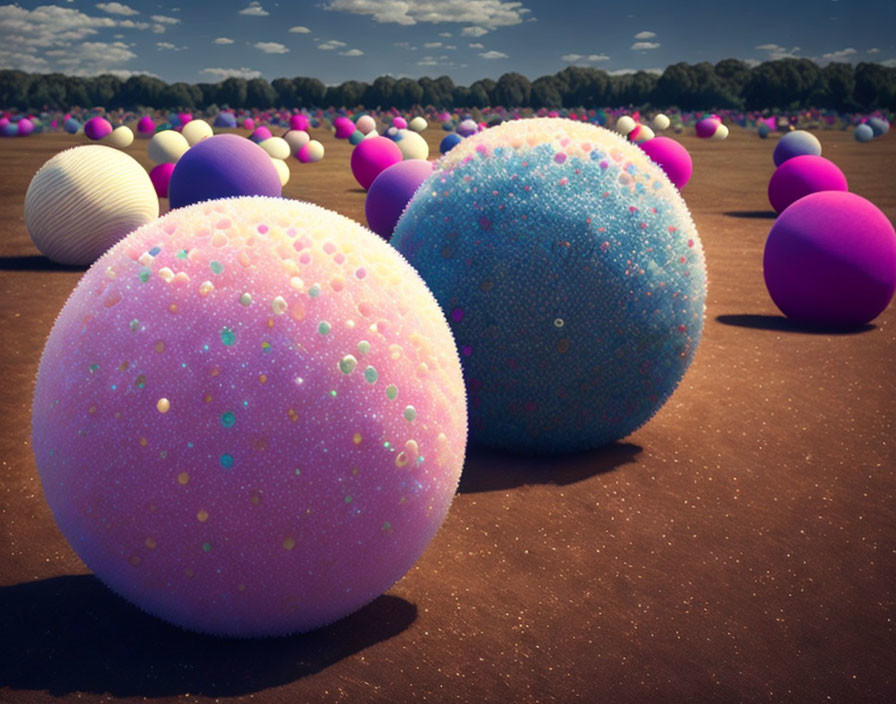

left=763, top=191, right=896, bottom=327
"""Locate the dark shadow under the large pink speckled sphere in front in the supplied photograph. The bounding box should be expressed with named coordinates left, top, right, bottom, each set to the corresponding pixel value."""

left=0, top=575, right=417, bottom=698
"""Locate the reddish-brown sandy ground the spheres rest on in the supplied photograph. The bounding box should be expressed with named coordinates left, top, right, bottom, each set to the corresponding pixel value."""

left=0, top=128, right=896, bottom=704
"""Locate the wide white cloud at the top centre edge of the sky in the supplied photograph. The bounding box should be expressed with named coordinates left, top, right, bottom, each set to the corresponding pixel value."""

left=324, top=0, right=530, bottom=29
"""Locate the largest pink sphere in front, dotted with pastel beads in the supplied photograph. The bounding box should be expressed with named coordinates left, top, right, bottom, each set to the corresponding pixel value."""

left=33, top=195, right=466, bottom=636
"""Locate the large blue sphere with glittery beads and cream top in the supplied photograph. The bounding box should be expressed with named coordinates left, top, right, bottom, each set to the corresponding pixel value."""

left=391, top=118, right=705, bottom=453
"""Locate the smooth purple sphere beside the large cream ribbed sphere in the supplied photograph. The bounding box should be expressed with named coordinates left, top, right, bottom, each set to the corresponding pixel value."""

left=168, top=134, right=281, bottom=208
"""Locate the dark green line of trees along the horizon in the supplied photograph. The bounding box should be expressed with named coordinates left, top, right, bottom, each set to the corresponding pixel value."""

left=0, top=58, right=896, bottom=112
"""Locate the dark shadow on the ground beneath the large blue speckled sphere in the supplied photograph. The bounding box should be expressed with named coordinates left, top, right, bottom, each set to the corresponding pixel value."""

left=458, top=442, right=642, bottom=494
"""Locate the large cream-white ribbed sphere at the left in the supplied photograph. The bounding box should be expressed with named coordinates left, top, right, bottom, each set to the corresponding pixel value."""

left=25, top=144, right=159, bottom=265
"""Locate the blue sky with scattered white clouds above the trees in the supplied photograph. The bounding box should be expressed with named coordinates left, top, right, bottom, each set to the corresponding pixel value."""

left=0, top=0, right=896, bottom=85
